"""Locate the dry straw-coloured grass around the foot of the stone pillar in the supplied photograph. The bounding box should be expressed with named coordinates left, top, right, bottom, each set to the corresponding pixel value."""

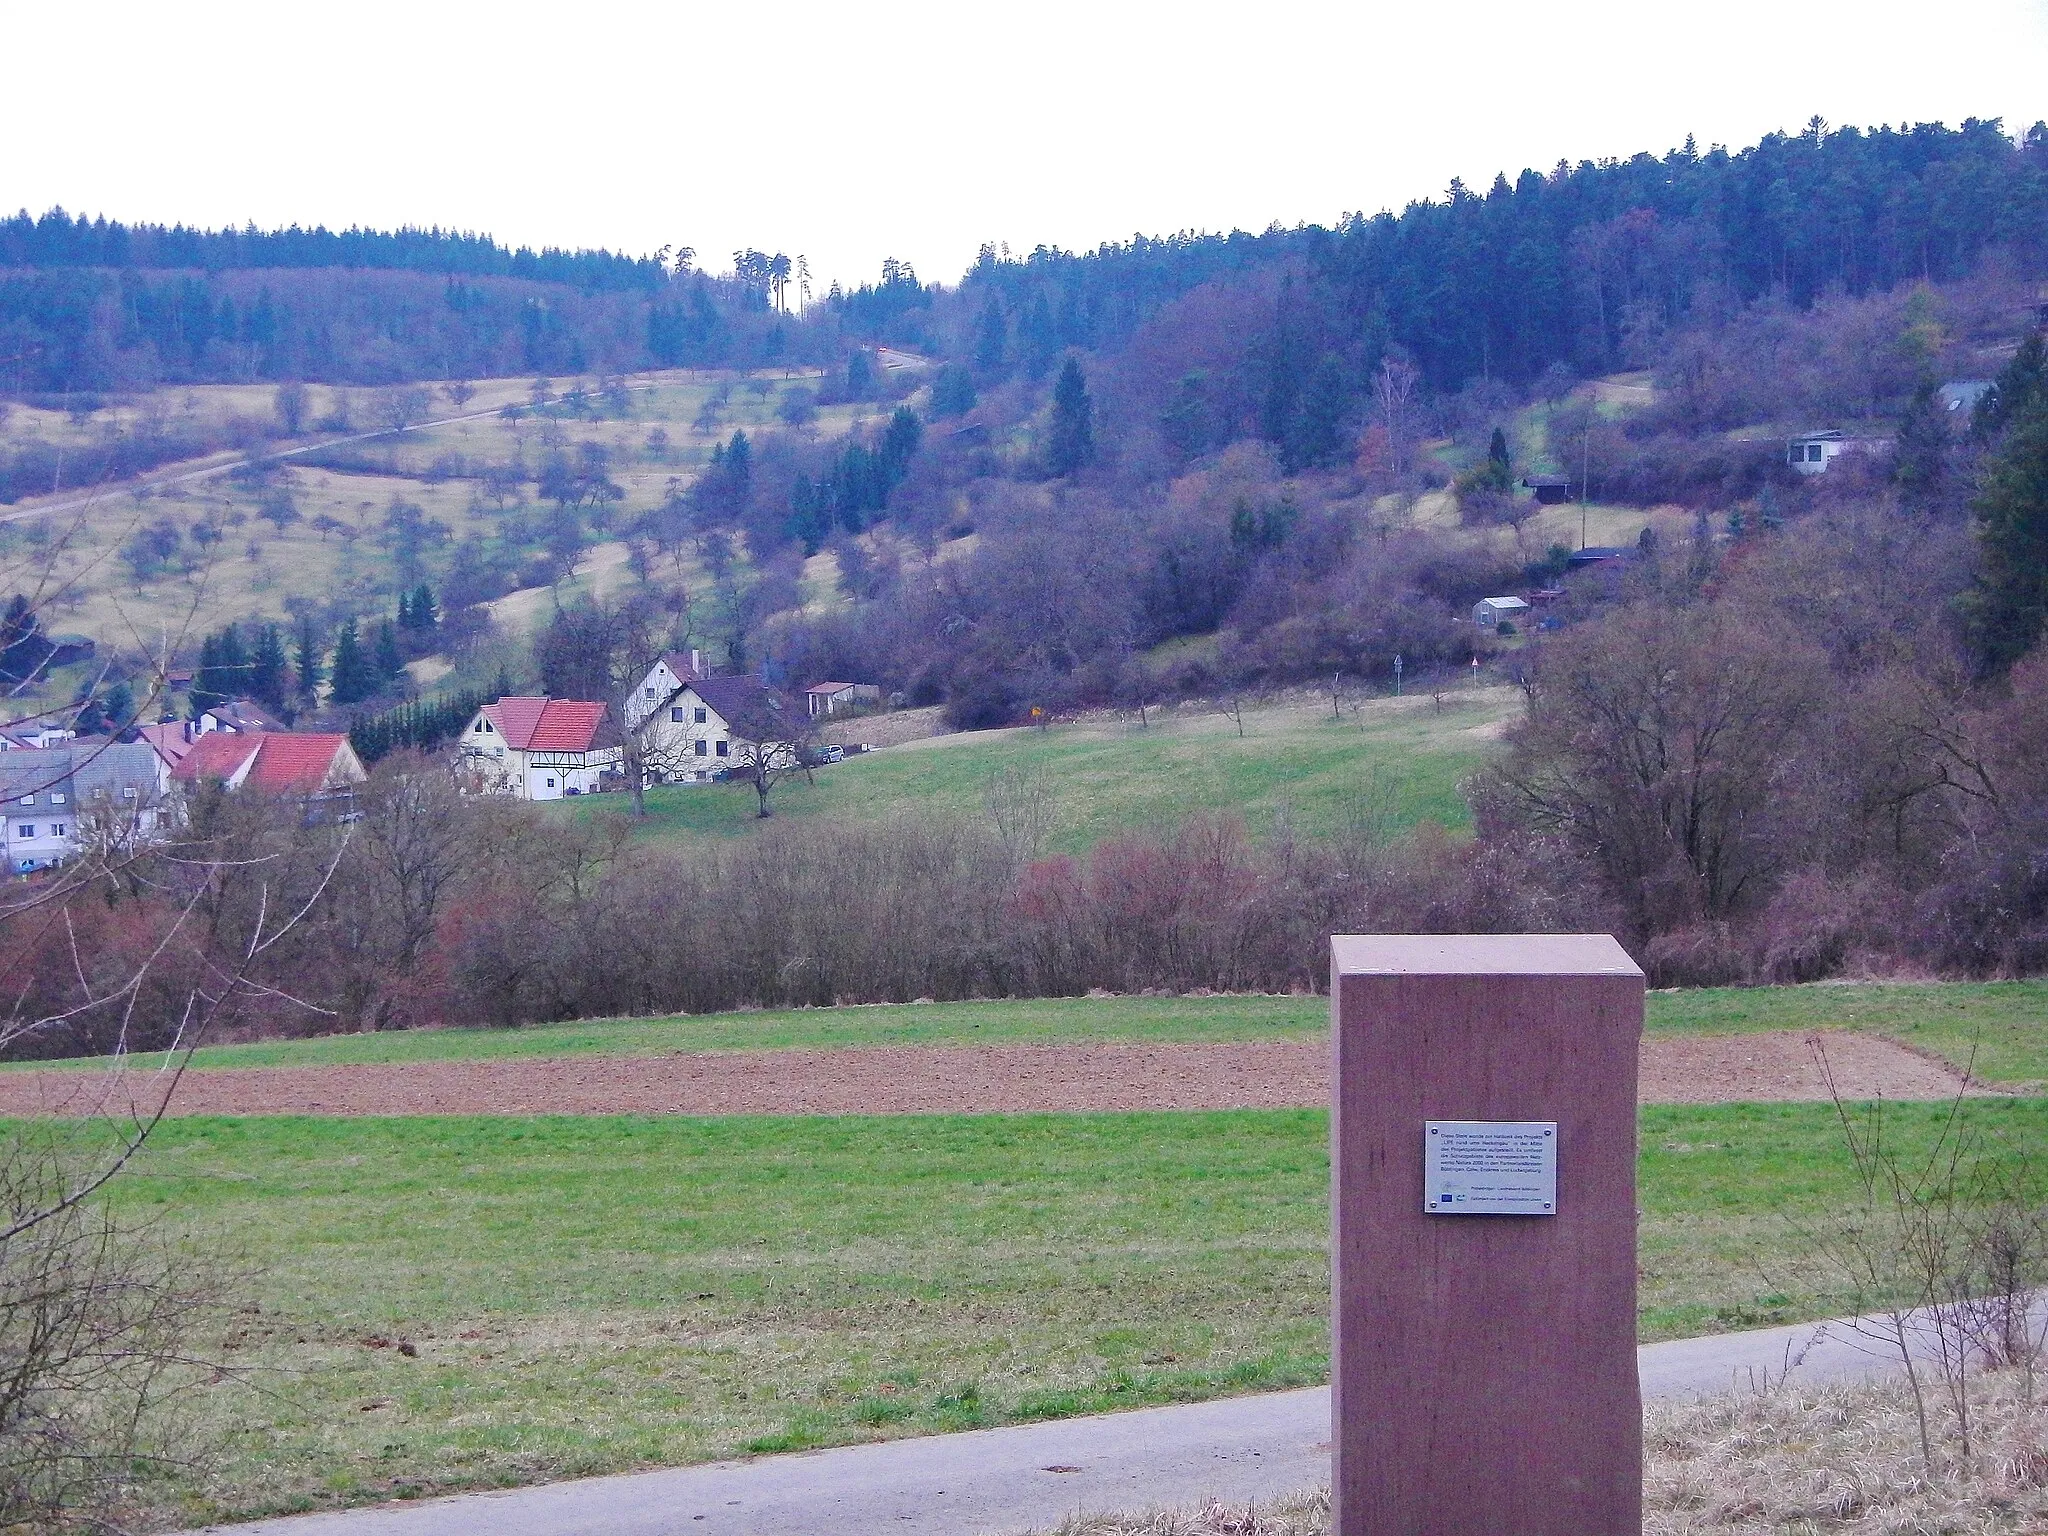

left=1024, top=1370, right=2048, bottom=1536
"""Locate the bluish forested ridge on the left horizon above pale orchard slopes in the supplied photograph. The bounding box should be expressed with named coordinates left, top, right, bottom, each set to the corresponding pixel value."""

left=0, top=209, right=827, bottom=395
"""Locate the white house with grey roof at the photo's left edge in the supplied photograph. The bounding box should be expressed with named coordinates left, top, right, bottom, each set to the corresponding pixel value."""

left=0, top=741, right=164, bottom=874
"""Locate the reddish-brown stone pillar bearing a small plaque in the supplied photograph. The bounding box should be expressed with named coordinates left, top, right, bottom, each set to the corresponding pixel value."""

left=1329, top=934, right=1642, bottom=1536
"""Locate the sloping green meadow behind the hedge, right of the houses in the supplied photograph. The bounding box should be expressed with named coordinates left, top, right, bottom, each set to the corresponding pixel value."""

left=593, top=688, right=1513, bottom=852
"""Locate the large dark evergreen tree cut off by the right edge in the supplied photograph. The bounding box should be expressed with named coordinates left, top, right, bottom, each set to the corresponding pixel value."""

left=1966, top=395, right=2048, bottom=674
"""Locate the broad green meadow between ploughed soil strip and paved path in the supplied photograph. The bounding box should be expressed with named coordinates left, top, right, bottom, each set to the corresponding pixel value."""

left=119, top=1100, right=2048, bottom=1516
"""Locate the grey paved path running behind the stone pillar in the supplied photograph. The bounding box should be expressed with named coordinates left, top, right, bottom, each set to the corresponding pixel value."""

left=192, top=1323, right=1896, bottom=1536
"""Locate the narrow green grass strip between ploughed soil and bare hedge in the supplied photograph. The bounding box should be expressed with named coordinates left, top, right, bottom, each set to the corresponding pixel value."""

left=28, top=981, right=2048, bottom=1083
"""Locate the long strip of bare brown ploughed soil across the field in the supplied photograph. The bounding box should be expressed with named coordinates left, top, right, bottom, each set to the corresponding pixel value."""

left=0, top=1032, right=1960, bottom=1114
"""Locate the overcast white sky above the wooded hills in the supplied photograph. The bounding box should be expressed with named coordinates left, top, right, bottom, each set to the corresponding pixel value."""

left=0, top=0, right=2048, bottom=287
